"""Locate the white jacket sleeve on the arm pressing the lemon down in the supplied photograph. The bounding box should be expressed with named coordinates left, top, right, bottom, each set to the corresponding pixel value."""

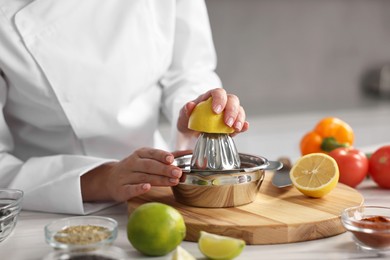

left=160, top=0, right=222, bottom=150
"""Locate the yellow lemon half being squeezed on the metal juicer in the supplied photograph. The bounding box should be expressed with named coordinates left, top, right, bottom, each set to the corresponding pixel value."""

left=188, top=97, right=234, bottom=134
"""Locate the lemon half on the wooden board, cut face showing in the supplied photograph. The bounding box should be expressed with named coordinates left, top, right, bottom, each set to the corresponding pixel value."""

left=290, top=153, right=339, bottom=198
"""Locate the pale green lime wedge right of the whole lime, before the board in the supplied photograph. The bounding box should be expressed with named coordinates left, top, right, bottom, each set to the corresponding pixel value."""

left=198, top=231, right=245, bottom=259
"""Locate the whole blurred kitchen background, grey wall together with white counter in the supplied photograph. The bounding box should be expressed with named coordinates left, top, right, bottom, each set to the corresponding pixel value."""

left=163, top=0, right=390, bottom=160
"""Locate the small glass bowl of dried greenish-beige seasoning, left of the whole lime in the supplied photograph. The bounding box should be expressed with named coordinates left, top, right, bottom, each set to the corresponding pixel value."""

left=45, top=216, right=118, bottom=252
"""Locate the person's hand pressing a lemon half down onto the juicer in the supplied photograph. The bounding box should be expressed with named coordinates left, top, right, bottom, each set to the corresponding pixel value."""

left=177, top=88, right=249, bottom=135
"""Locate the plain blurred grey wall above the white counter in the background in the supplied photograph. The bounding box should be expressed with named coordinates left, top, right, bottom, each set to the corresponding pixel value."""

left=206, top=0, right=390, bottom=116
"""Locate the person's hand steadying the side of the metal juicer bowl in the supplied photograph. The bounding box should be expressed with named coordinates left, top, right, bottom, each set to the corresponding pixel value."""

left=81, top=148, right=182, bottom=202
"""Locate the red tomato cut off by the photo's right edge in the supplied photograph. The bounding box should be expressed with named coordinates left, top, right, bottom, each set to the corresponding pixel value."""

left=369, top=145, right=390, bottom=189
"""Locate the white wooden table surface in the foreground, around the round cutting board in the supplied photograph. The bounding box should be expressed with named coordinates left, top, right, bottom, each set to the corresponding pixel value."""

left=0, top=180, right=390, bottom=260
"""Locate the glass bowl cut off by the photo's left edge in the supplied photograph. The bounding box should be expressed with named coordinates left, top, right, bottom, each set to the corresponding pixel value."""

left=0, top=189, right=23, bottom=242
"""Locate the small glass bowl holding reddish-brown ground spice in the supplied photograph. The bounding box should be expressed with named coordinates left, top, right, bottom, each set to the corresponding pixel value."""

left=341, top=206, right=390, bottom=251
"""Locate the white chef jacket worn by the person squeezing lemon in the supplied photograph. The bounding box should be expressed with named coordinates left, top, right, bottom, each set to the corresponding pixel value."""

left=0, top=0, right=221, bottom=214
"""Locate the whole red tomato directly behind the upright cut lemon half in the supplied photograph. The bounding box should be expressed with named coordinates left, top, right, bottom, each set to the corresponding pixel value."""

left=329, top=147, right=368, bottom=187
